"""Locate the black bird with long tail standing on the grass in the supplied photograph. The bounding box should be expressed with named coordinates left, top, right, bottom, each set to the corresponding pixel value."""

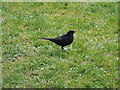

left=41, top=30, right=76, bottom=49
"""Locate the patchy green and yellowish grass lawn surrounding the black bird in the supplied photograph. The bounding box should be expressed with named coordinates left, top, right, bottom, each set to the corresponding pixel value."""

left=2, top=2, right=118, bottom=88
